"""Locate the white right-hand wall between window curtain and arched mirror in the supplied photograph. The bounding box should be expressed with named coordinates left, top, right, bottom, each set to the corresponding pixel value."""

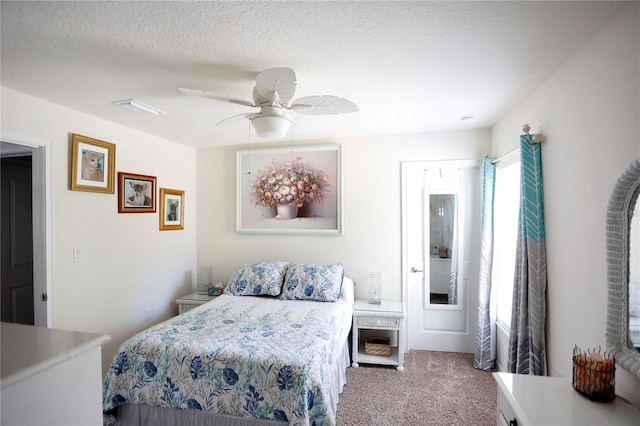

left=492, top=3, right=640, bottom=405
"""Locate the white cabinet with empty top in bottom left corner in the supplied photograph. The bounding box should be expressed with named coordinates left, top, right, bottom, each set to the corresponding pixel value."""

left=0, top=322, right=110, bottom=426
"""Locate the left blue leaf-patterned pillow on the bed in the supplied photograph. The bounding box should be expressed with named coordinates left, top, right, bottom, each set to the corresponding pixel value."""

left=224, top=262, right=289, bottom=296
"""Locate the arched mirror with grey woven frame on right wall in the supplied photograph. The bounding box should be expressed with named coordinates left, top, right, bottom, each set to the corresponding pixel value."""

left=606, top=158, right=640, bottom=378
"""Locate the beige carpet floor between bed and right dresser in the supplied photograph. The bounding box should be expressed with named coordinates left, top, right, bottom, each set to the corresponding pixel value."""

left=336, top=351, right=497, bottom=426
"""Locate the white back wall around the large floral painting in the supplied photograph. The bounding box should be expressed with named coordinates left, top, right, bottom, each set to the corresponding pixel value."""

left=197, top=130, right=490, bottom=300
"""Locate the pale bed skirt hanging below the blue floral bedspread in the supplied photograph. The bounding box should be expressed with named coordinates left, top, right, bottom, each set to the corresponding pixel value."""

left=115, top=339, right=351, bottom=426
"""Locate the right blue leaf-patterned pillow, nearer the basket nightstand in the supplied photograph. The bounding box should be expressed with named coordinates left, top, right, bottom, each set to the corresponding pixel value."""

left=282, top=263, right=344, bottom=302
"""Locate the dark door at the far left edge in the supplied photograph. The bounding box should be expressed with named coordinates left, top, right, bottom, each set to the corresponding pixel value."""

left=0, top=156, right=34, bottom=324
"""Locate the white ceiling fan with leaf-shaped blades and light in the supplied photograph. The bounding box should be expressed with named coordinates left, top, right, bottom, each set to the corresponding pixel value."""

left=180, top=67, right=358, bottom=139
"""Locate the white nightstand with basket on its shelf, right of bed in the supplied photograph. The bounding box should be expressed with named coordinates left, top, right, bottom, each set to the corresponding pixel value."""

left=351, top=300, right=404, bottom=371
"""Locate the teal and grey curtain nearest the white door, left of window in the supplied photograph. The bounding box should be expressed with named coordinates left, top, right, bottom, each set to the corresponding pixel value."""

left=473, top=157, right=496, bottom=370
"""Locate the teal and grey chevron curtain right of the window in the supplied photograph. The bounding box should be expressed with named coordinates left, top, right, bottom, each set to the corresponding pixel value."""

left=507, top=134, right=547, bottom=376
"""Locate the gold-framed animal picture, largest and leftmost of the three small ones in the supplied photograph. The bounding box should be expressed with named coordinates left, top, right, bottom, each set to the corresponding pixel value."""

left=69, top=133, right=116, bottom=194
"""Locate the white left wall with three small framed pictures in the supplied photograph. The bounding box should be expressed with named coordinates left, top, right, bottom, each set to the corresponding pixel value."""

left=1, top=87, right=196, bottom=372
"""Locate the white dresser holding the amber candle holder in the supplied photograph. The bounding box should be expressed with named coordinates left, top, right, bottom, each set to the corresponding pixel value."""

left=493, top=373, right=640, bottom=426
